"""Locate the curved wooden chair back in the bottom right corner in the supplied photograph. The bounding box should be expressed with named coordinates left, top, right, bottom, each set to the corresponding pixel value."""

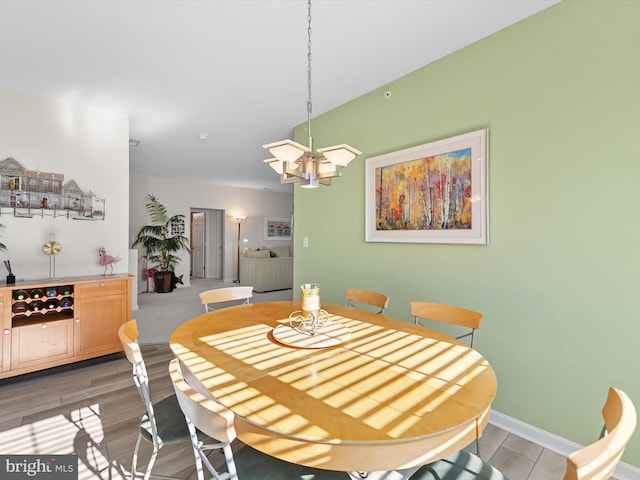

left=564, top=387, right=637, bottom=480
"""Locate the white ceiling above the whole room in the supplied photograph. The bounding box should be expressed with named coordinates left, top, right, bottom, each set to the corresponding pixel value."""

left=0, top=0, right=557, bottom=191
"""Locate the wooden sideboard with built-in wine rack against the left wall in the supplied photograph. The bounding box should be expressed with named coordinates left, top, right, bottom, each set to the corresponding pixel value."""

left=0, top=275, right=132, bottom=378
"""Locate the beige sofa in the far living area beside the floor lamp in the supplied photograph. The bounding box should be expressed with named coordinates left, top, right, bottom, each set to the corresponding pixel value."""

left=240, top=245, right=293, bottom=293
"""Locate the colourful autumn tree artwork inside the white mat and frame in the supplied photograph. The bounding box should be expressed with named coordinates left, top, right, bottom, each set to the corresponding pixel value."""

left=375, top=148, right=472, bottom=230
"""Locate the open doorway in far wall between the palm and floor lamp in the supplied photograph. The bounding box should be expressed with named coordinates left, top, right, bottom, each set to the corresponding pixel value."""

left=190, top=208, right=224, bottom=279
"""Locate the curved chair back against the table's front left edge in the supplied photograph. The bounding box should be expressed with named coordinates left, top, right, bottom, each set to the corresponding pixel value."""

left=169, top=358, right=236, bottom=443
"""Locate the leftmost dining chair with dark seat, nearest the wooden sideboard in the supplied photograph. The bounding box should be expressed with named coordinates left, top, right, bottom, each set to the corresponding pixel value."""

left=118, top=320, right=202, bottom=480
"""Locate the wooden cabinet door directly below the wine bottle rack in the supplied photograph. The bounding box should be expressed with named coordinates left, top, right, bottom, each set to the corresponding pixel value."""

left=11, top=319, right=73, bottom=370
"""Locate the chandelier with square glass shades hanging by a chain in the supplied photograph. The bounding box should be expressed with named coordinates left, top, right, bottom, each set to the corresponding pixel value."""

left=263, top=0, right=362, bottom=188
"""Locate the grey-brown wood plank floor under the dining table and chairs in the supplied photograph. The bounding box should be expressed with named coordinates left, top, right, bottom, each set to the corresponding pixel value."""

left=0, top=345, right=580, bottom=480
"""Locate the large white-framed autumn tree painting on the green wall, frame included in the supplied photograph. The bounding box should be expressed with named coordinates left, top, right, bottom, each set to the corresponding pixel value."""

left=365, top=129, right=488, bottom=245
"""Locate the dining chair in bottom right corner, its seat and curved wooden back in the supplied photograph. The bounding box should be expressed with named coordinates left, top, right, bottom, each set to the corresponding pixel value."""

left=409, top=387, right=637, bottom=480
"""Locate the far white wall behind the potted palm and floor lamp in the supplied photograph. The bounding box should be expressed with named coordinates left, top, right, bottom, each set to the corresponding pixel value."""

left=129, top=172, right=293, bottom=286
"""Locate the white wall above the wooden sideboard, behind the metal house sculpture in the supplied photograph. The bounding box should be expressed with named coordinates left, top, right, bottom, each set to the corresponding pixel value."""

left=0, top=89, right=129, bottom=283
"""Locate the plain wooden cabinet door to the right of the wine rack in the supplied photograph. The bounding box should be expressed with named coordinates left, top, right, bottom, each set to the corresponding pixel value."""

left=74, top=280, right=131, bottom=357
